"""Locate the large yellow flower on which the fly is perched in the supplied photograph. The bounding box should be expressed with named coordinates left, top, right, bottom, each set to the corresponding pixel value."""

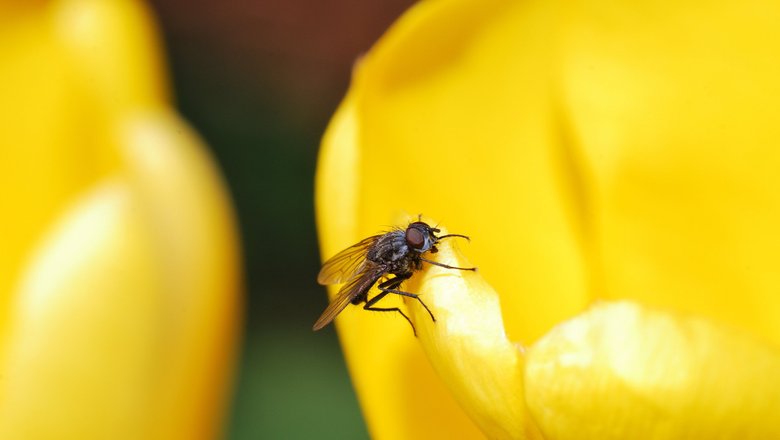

left=317, top=0, right=780, bottom=439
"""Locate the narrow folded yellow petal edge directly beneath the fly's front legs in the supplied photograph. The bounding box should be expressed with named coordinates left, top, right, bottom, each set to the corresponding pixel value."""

left=405, top=232, right=541, bottom=439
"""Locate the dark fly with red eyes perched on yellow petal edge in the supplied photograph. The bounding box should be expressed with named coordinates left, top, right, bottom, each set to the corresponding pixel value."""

left=313, top=221, right=476, bottom=336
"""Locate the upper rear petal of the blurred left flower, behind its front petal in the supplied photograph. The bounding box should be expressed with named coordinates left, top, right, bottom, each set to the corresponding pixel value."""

left=0, top=0, right=167, bottom=320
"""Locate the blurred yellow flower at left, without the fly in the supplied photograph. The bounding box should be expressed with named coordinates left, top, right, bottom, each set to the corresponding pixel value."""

left=0, top=0, right=239, bottom=439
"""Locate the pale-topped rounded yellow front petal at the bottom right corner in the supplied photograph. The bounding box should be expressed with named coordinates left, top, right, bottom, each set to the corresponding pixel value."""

left=525, top=302, right=780, bottom=440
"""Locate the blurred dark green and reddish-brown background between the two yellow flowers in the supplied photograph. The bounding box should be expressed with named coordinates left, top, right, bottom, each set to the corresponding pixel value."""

left=144, top=0, right=413, bottom=439
